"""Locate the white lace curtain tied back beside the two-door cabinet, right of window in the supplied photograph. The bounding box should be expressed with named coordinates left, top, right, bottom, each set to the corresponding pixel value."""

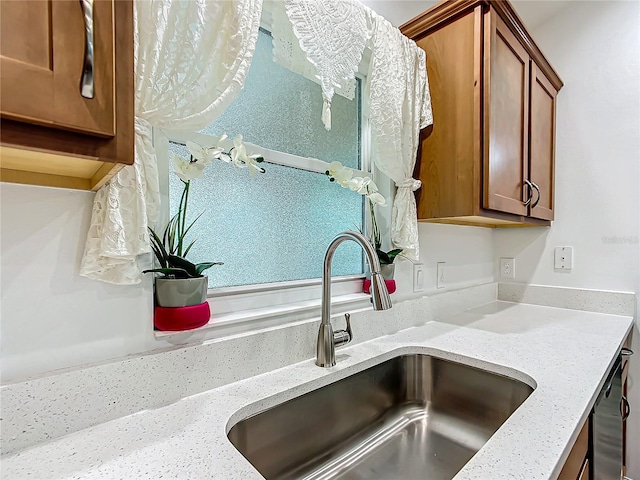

left=368, top=16, right=433, bottom=260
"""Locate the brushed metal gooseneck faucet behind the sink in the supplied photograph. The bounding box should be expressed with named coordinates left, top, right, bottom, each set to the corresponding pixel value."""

left=316, top=231, right=391, bottom=367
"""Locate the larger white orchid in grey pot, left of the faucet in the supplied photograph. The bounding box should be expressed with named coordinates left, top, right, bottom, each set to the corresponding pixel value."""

left=142, top=134, right=265, bottom=307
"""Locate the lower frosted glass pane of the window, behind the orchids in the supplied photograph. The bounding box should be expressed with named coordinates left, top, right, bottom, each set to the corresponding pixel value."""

left=169, top=143, right=363, bottom=288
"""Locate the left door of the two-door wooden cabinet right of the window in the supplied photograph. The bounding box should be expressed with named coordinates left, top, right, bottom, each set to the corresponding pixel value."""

left=483, top=10, right=530, bottom=215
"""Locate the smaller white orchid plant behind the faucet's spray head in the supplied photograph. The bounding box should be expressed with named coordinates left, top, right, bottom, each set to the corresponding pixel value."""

left=325, top=162, right=402, bottom=280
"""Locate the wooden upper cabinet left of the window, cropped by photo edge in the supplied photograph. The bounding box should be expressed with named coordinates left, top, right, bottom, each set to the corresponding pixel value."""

left=0, top=0, right=134, bottom=190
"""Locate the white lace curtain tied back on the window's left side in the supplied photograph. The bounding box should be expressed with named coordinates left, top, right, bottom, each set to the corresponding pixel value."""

left=80, top=0, right=262, bottom=285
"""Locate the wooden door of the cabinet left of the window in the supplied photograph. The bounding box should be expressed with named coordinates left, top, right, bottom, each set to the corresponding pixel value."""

left=0, top=0, right=115, bottom=137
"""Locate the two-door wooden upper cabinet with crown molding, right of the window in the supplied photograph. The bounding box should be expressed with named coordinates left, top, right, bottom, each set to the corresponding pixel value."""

left=400, top=0, right=562, bottom=227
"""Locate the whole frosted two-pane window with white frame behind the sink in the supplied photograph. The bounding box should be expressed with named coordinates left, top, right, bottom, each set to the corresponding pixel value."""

left=154, top=29, right=376, bottom=330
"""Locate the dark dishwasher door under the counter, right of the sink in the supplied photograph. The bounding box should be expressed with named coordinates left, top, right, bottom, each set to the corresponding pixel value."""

left=592, top=356, right=622, bottom=480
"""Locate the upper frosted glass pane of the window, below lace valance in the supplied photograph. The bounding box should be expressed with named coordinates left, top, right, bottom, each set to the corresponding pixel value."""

left=202, top=30, right=361, bottom=168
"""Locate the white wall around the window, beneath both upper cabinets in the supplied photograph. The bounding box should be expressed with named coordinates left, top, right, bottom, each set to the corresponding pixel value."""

left=0, top=183, right=493, bottom=382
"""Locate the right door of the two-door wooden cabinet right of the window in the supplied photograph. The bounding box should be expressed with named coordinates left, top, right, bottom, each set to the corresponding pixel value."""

left=529, top=61, right=558, bottom=220
